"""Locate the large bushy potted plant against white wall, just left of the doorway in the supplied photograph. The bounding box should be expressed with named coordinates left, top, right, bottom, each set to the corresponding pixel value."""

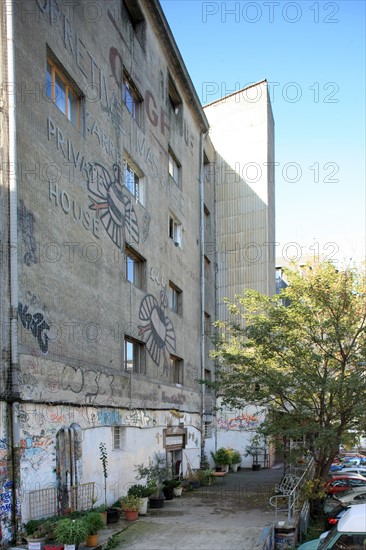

left=135, top=453, right=171, bottom=508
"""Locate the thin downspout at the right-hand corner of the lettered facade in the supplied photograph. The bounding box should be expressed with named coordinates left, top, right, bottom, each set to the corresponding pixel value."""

left=200, top=132, right=208, bottom=460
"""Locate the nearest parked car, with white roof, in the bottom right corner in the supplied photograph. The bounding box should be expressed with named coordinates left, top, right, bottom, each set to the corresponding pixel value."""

left=297, top=504, right=366, bottom=550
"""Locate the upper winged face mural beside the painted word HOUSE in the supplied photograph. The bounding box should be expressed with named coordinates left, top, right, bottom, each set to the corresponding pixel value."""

left=88, top=162, right=139, bottom=250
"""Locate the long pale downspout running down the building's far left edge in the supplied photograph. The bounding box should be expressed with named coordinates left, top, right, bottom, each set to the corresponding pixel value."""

left=5, top=0, right=19, bottom=542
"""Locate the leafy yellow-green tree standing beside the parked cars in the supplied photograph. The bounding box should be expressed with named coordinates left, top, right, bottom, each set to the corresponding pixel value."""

left=213, top=262, right=366, bottom=479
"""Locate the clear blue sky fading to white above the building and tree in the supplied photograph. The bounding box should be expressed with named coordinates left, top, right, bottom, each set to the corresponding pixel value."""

left=161, top=0, right=366, bottom=268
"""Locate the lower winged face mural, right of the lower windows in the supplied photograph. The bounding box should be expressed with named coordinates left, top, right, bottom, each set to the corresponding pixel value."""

left=139, top=290, right=176, bottom=376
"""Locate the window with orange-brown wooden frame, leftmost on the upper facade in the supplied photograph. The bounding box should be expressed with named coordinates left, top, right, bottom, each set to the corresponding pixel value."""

left=46, top=57, right=80, bottom=130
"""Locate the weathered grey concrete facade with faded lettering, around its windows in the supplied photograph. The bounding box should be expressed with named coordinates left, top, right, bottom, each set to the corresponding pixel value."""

left=0, top=0, right=209, bottom=540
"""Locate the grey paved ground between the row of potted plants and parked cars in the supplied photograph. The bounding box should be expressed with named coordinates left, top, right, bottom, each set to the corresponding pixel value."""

left=93, top=466, right=285, bottom=550
